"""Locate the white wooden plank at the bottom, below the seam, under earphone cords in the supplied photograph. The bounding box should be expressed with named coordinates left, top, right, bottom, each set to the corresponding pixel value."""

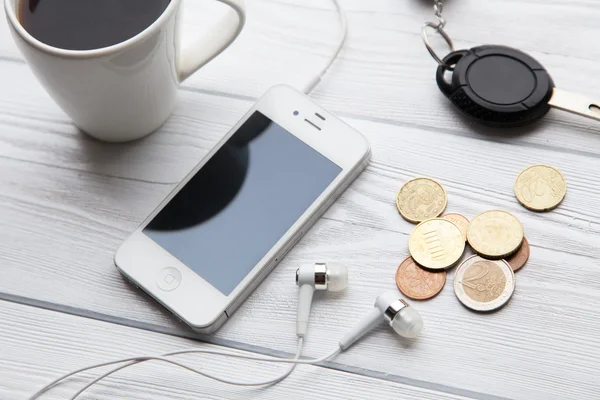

left=0, top=301, right=478, bottom=400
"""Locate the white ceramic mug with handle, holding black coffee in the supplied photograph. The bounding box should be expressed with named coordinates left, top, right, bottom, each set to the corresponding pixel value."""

left=4, top=0, right=245, bottom=142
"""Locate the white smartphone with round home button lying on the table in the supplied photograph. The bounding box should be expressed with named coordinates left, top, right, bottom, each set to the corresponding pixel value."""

left=115, top=85, right=370, bottom=333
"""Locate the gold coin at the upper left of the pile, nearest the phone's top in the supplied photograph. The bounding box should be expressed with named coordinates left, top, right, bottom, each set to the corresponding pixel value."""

left=396, top=178, right=448, bottom=223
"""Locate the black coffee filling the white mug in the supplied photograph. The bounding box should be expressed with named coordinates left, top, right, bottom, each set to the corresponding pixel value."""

left=18, top=0, right=170, bottom=50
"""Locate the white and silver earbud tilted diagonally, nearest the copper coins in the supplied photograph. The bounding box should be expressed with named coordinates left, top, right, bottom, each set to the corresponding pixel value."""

left=340, top=292, right=423, bottom=350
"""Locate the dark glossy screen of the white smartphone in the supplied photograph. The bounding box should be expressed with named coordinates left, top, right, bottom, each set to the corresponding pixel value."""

left=144, top=111, right=342, bottom=295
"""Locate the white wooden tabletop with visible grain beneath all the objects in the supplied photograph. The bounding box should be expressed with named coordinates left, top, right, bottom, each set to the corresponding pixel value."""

left=0, top=0, right=600, bottom=400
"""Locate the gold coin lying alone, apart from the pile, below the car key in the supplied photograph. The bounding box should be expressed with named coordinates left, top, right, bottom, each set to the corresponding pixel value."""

left=515, top=165, right=567, bottom=211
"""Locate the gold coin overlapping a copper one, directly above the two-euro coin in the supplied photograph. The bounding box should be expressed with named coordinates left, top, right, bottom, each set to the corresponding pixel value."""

left=467, top=210, right=524, bottom=259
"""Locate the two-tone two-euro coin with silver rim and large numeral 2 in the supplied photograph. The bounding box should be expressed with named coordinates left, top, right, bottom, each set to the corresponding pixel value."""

left=454, top=256, right=516, bottom=311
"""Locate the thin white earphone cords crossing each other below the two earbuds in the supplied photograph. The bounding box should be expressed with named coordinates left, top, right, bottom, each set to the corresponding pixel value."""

left=29, top=340, right=342, bottom=400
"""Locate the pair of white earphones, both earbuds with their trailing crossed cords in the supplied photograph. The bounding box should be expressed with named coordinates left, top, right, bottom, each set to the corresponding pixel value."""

left=29, top=263, right=423, bottom=400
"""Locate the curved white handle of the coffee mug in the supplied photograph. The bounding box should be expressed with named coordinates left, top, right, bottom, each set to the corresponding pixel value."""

left=177, top=0, right=246, bottom=82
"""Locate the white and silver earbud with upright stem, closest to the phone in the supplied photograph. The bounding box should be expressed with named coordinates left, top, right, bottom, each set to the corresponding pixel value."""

left=296, top=263, right=348, bottom=337
